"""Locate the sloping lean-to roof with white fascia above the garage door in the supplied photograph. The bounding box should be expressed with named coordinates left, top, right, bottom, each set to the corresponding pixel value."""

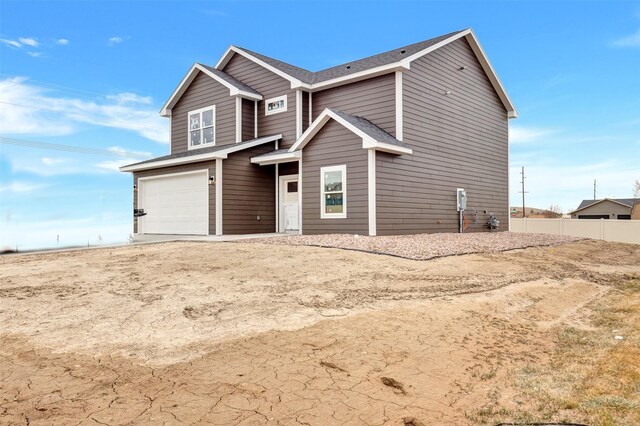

left=120, top=134, right=282, bottom=172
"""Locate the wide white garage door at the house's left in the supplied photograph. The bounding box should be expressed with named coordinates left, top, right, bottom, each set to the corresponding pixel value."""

left=138, top=171, right=209, bottom=235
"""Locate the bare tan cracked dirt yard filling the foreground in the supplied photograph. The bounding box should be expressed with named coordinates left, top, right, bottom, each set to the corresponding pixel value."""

left=0, top=241, right=640, bottom=425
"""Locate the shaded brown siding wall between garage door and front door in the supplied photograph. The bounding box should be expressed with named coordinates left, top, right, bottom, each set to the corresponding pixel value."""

left=222, top=144, right=276, bottom=235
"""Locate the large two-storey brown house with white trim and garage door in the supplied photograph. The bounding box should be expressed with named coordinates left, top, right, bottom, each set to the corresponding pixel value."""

left=120, top=29, right=517, bottom=235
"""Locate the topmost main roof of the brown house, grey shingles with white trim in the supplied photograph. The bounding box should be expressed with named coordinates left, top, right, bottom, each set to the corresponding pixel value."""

left=215, top=28, right=518, bottom=118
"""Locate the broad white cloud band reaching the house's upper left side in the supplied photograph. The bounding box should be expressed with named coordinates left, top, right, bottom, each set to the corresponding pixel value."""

left=0, top=77, right=169, bottom=143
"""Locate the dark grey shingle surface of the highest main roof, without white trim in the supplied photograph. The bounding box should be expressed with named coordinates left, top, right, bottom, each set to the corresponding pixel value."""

left=232, top=30, right=464, bottom=84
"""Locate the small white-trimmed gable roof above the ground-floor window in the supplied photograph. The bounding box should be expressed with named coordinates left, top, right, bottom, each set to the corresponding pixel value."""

left=289, top=108, right=413, bottom=154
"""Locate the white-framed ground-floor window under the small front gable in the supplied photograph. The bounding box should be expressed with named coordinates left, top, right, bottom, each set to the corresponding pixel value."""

left=320, top=165, right=347, bottom=219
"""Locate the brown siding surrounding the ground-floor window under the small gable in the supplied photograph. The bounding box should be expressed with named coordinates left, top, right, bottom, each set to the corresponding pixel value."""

left=302, top=120, right=369, bottom=235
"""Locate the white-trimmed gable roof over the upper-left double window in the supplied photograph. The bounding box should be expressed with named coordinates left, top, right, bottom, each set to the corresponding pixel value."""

left=160, top=62, right=262, bottom=117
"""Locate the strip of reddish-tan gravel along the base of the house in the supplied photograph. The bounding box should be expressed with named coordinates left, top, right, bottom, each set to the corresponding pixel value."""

left=241, top=232, right=581, bottom=260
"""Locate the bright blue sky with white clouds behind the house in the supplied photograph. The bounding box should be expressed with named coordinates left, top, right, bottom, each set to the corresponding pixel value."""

left=0, top=0, right=640, bottom=249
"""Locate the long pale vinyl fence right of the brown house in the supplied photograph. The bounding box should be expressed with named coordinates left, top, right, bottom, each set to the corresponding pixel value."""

left=509, top=218, right=640, bottom=244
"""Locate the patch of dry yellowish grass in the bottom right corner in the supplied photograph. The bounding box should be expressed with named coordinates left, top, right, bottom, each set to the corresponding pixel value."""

left=468, top=276, right=640, bottom=426
